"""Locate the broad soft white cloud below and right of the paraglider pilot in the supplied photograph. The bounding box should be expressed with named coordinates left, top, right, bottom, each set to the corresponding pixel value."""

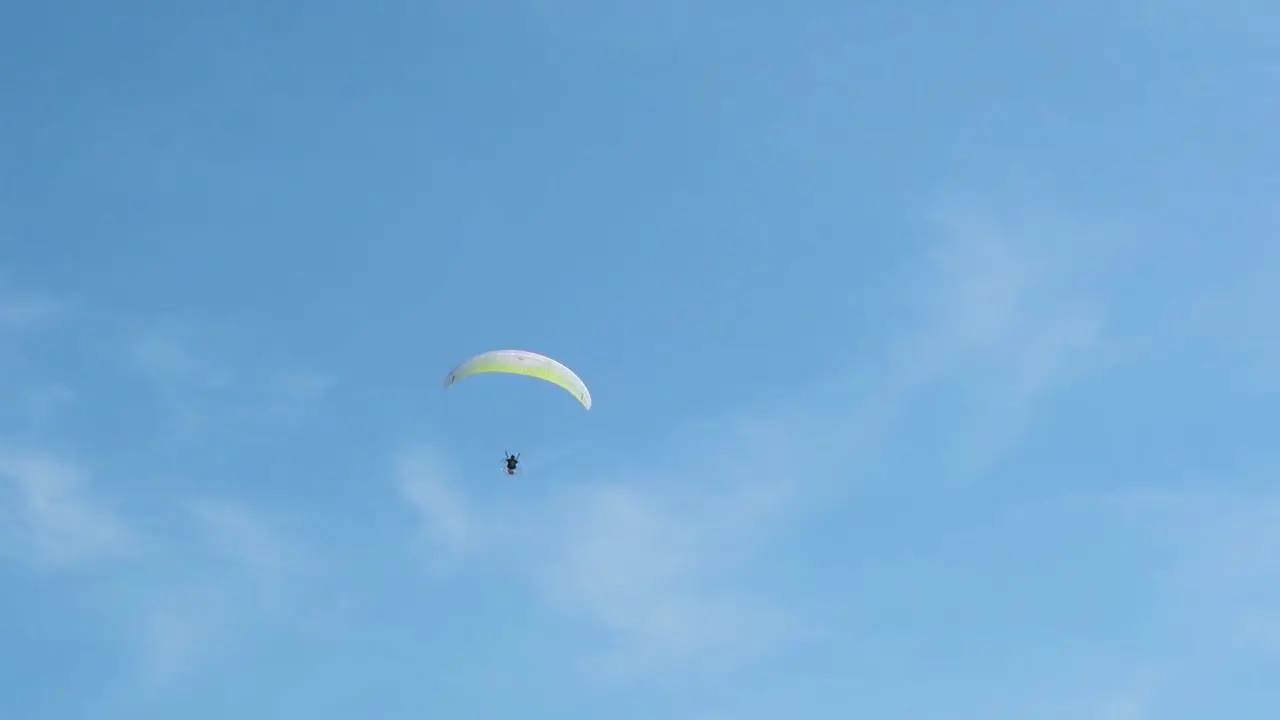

left=524, top=471, right=804, bottom=671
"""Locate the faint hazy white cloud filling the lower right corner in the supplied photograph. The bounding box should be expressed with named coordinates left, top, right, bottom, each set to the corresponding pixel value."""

left=1014, top=473, right=1280, bottom=707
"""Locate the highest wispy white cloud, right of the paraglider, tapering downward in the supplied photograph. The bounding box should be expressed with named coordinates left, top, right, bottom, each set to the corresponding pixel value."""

left=849, top=202, right=1111, bottom=480
